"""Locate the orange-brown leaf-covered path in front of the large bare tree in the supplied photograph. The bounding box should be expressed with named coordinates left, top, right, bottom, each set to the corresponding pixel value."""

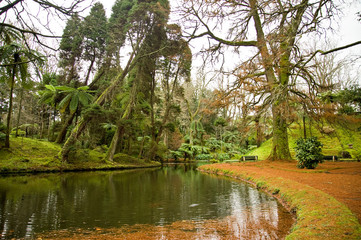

left=222, top=162, right=361, bottom=222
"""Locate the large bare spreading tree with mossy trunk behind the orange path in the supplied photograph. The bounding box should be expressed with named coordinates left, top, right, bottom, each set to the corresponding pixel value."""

left=182, top=0, right=337, bottom=160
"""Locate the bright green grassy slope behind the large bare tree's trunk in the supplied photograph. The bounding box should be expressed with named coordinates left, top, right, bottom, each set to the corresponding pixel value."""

left=247, top=124, right=361, bottom=160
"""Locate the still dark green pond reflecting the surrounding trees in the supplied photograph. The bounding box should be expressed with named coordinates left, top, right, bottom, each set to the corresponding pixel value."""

left=0, top=165, right=293, bottom=239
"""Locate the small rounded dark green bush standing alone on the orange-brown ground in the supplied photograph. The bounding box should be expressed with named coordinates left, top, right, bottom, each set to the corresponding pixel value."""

left=295, top=137, right=323, bottom=169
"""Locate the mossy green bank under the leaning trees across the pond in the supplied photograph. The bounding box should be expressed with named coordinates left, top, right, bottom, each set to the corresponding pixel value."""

left=0, top=138, right=160, bottom=174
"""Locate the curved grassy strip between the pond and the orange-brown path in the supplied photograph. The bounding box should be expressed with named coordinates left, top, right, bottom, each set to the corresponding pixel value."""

left=199, top=164, right=361, bottom=240
